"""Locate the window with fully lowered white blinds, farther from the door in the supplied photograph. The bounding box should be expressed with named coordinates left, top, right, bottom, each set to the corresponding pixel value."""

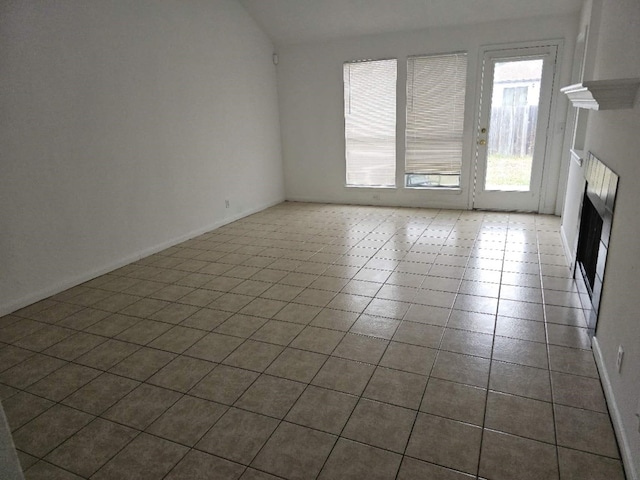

left=343, top=59, right=397, bottom=187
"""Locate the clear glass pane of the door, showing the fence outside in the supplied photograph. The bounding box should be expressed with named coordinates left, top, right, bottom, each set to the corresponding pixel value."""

left=484, top=59, right=543, bottom=192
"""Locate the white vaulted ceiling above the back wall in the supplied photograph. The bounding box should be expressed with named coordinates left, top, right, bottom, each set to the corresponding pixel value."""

left=239, top=0, right=583, bottom=46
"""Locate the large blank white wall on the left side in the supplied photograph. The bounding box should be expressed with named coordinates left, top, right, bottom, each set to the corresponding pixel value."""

left=0, top=0, right=284, bottom=314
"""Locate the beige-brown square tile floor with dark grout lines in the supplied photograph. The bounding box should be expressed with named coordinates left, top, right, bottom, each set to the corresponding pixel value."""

left=0, top=203, right=624, bottom=480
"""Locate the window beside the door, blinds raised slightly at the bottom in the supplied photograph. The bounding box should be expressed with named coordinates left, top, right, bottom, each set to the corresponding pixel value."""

left=405, top=53, right=467, bottom=188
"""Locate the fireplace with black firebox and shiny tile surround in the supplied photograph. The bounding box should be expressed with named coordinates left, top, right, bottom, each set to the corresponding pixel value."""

left=574, top=153, right=618, bottom=336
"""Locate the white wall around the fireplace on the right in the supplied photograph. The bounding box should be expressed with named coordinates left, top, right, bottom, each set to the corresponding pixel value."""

left=564, top=0, right=640, bottom=479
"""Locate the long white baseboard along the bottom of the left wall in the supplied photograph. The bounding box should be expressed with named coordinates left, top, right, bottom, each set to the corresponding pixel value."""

left=0, top=199, right=284, bottom=316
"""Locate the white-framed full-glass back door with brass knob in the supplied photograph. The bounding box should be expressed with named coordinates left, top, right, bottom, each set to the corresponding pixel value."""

left=473, top=46, right=556, bottom=212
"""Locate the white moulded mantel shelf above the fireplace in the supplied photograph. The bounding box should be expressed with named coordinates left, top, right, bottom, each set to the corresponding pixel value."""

left=560, top=78, right=640, bottom=110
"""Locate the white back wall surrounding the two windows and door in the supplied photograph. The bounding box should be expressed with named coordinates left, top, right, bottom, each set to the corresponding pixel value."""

left=278, top=16, right=578, bottom=213
